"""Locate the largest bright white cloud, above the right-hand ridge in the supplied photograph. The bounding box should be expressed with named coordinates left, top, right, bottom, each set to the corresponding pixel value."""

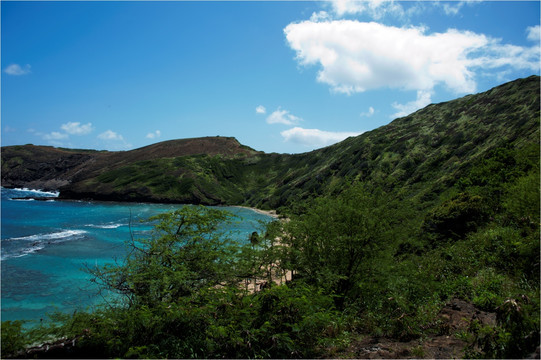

left=284, top=20, right=539, bottom=94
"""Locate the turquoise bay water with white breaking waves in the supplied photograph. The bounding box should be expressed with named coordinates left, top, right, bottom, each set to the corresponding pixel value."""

left=1, top=188, right=272, bottom=323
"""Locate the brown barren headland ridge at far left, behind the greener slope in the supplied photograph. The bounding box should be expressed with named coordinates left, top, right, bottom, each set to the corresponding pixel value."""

left=2, top=136, right=258, bottom=194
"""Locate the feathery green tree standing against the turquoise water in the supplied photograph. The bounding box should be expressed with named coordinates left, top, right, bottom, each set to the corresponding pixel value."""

left=89, top=206, right=237, bottom=306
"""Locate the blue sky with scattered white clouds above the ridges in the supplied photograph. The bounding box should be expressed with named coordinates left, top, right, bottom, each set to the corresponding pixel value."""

left=1, top=0, right=540, bottom=153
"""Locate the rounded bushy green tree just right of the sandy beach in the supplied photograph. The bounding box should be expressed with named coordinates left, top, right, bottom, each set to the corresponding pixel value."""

left=284, top=185, right=389, bottom=303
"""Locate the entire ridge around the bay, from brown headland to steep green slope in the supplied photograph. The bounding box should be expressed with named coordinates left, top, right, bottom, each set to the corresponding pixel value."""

left=2, top=76, right=540, bottom=209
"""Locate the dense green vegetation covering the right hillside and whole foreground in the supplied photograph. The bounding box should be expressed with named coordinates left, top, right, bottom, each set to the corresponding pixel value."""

left=2, top=78, right=541, bottom=358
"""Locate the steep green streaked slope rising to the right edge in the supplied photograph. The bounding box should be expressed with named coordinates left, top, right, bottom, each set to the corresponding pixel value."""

left=270, top=76, right=540, bottom=210
